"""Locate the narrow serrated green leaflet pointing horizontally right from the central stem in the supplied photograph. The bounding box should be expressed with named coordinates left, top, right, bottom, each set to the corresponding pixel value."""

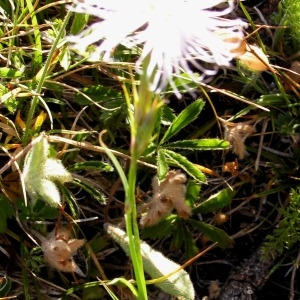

left=164, top=139, right=230, bottom=151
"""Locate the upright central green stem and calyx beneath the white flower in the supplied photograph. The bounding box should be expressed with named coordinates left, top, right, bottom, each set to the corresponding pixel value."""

left=124, top=57, right=162, bottom=300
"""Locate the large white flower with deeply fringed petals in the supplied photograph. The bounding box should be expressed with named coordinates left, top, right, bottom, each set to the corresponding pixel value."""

left=70, top=0, right=246, bottom=93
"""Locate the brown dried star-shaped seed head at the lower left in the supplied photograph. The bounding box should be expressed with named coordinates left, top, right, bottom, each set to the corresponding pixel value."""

left=41, top=228, right=85, bottom=277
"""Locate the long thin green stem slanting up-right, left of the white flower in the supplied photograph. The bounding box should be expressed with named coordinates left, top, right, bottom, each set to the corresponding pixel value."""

left=23, top=11, right=73, bottom=144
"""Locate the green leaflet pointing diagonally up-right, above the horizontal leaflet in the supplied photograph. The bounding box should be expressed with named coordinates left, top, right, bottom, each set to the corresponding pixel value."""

left=160, top=99, right=204, bottom=145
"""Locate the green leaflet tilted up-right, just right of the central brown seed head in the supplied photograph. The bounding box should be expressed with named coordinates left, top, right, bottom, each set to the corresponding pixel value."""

left=193, top=188, right=235, bottom=214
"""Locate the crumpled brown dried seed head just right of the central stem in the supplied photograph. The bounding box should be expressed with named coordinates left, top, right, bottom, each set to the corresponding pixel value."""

left=140, top=170, right=191, bottom=226
